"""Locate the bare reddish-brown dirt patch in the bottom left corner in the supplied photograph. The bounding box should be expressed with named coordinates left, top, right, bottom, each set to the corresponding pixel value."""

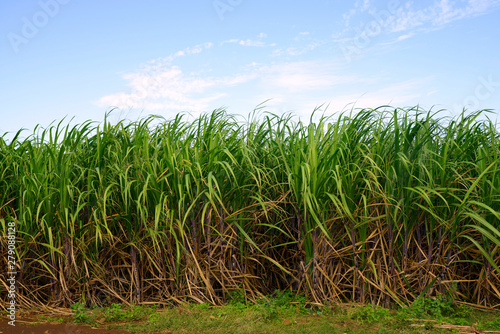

left=0, top=319, right=152, bottom=334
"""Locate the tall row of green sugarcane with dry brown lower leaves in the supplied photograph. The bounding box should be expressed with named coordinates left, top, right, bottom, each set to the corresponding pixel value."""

left=0, top=107, right=500, bottom=306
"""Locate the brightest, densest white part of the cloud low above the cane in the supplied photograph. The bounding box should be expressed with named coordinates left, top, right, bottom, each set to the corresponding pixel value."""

left=97, top=48, right=373, bottom=117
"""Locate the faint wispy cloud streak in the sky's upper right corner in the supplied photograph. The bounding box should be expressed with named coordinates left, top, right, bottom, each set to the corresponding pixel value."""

left=332, top=0, right=500, bottom=62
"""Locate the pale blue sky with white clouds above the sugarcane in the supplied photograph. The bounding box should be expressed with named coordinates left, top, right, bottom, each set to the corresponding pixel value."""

left=0, top=0, right=500, bottom=135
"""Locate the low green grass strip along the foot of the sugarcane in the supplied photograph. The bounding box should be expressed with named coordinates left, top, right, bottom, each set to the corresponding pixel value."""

left=58, top=292, right=500, bottom=333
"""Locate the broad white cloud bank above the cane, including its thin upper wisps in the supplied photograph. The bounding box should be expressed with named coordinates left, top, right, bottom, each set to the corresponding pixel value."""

left=97, top=32, right=434, bottom=118
